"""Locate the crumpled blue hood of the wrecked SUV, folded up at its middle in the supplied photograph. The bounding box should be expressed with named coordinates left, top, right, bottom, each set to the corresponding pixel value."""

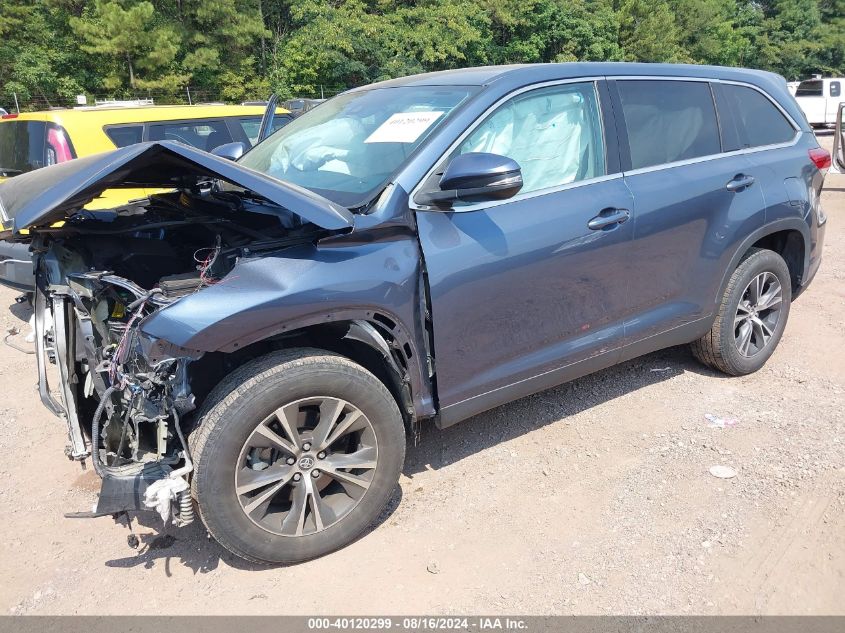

left=0, top=141, right=354, bottom=235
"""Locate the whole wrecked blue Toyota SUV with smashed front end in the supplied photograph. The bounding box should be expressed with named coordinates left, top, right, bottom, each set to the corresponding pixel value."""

left=0, top=63, right=830, bottom=562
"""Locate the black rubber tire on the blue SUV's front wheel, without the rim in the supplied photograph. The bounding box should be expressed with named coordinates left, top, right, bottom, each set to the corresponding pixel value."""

left=191, top=348, right=405, bottom=563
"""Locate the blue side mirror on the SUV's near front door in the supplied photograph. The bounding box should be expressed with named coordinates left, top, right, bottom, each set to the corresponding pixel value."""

left=414, top=152, right=522, bottom=206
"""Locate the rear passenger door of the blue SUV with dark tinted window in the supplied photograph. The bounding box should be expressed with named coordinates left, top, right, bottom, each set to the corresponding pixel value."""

left=612, top=78, right=765, bottom=358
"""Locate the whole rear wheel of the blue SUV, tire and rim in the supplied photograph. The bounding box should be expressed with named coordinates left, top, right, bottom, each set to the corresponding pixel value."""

left=692, top=249, right=792, bottom=376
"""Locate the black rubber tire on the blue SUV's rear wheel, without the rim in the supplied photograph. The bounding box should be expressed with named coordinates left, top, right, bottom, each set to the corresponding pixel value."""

left=691, top=248, right=792, bottom=376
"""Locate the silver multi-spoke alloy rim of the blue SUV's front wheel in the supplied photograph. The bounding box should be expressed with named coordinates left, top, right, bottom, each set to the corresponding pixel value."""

left=235, top=397, right=378, bottom=536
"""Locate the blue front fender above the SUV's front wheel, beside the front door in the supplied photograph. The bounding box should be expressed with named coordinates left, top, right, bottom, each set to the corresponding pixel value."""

left=140, top=231, right=431, bottom=418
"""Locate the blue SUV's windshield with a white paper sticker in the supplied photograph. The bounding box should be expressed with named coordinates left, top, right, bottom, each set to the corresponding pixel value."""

left=239, top=86, right=477, bottom=208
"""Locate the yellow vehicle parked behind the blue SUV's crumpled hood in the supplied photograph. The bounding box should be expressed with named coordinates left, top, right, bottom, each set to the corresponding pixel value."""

left=0, top=104, right=292, bottom=291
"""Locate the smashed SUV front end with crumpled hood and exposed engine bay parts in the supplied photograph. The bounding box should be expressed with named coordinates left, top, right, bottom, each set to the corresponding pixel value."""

left=0, top=143, right=351, bottom=524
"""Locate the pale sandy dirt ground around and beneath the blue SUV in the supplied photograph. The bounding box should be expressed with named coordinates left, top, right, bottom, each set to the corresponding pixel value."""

left=0, top=136, right=845, bottom=614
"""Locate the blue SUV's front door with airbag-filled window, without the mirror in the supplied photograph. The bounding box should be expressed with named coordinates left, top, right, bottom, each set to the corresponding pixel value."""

left=416, top=81, right=633, bottom=424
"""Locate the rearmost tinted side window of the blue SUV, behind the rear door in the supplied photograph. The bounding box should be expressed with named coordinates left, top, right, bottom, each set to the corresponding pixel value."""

left=719, top=84, right=795, bottom=150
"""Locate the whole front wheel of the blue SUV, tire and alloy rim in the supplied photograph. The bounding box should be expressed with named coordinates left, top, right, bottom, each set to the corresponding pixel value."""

left=193, top=349, right=405, bottom=563
